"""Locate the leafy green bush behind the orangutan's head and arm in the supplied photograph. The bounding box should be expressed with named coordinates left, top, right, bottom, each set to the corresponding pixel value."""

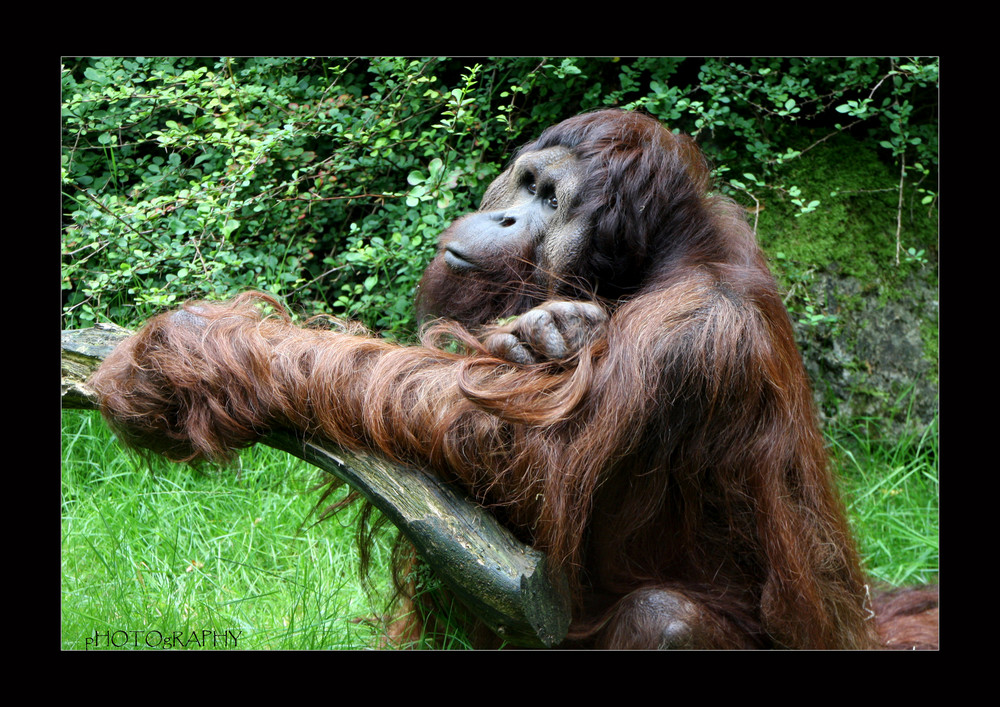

left=62, top=57, right=938, bottom=336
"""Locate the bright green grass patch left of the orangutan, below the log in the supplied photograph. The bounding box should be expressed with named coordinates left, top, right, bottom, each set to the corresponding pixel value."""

left=61, top=413, right=396, bottom=649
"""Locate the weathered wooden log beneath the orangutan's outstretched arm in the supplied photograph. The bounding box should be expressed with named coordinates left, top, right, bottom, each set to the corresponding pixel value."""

left=62, top=325, right=570, bottom=648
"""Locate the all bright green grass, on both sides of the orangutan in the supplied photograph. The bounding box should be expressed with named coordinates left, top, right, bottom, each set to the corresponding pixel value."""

left=61, top=412, right=938, bottom=649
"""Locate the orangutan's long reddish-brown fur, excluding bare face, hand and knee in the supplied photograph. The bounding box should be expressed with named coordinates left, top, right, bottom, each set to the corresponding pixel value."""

left=91, top=112, right=937, bottom=648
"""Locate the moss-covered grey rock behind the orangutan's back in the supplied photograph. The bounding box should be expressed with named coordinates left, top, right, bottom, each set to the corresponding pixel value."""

left=758, top=136, right=938, bottom=436
